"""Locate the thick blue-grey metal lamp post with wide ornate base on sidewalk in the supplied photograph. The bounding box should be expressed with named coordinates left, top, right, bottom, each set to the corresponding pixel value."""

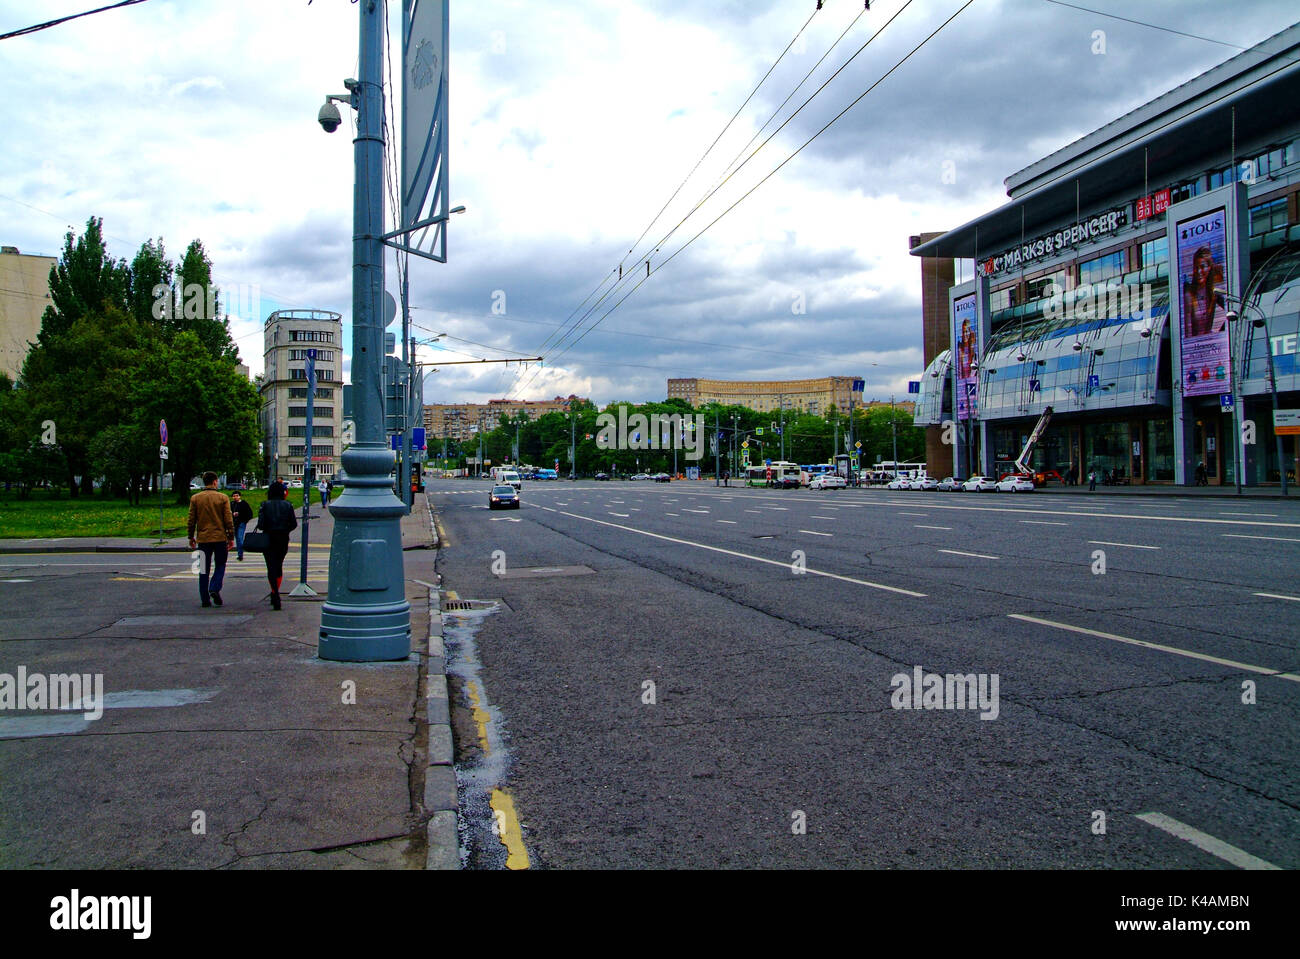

left=317, top=3, right=411, bottom=663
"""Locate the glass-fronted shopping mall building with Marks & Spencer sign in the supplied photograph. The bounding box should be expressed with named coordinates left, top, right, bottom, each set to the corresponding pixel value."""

left=911, top=25, right=1300, bottom=486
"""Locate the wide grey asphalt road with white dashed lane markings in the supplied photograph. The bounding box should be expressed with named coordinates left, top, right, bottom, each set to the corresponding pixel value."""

left=429, top=481, right=1300, bottom=869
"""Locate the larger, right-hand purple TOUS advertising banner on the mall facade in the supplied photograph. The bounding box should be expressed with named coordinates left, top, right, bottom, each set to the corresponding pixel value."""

left=1174, top=208, right=1232, bottom=396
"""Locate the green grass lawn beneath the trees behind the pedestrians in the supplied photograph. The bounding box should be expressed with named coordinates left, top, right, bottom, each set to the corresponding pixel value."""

left=0, top=487, right=325, bottom=539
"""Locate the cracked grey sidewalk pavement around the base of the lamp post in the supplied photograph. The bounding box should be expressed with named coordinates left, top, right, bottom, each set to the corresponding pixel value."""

left=0, top=495, right=459, bottom=869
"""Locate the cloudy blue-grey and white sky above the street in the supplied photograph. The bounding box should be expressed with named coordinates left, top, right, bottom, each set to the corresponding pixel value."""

left=0, top=0, right=1296, bottom=404
